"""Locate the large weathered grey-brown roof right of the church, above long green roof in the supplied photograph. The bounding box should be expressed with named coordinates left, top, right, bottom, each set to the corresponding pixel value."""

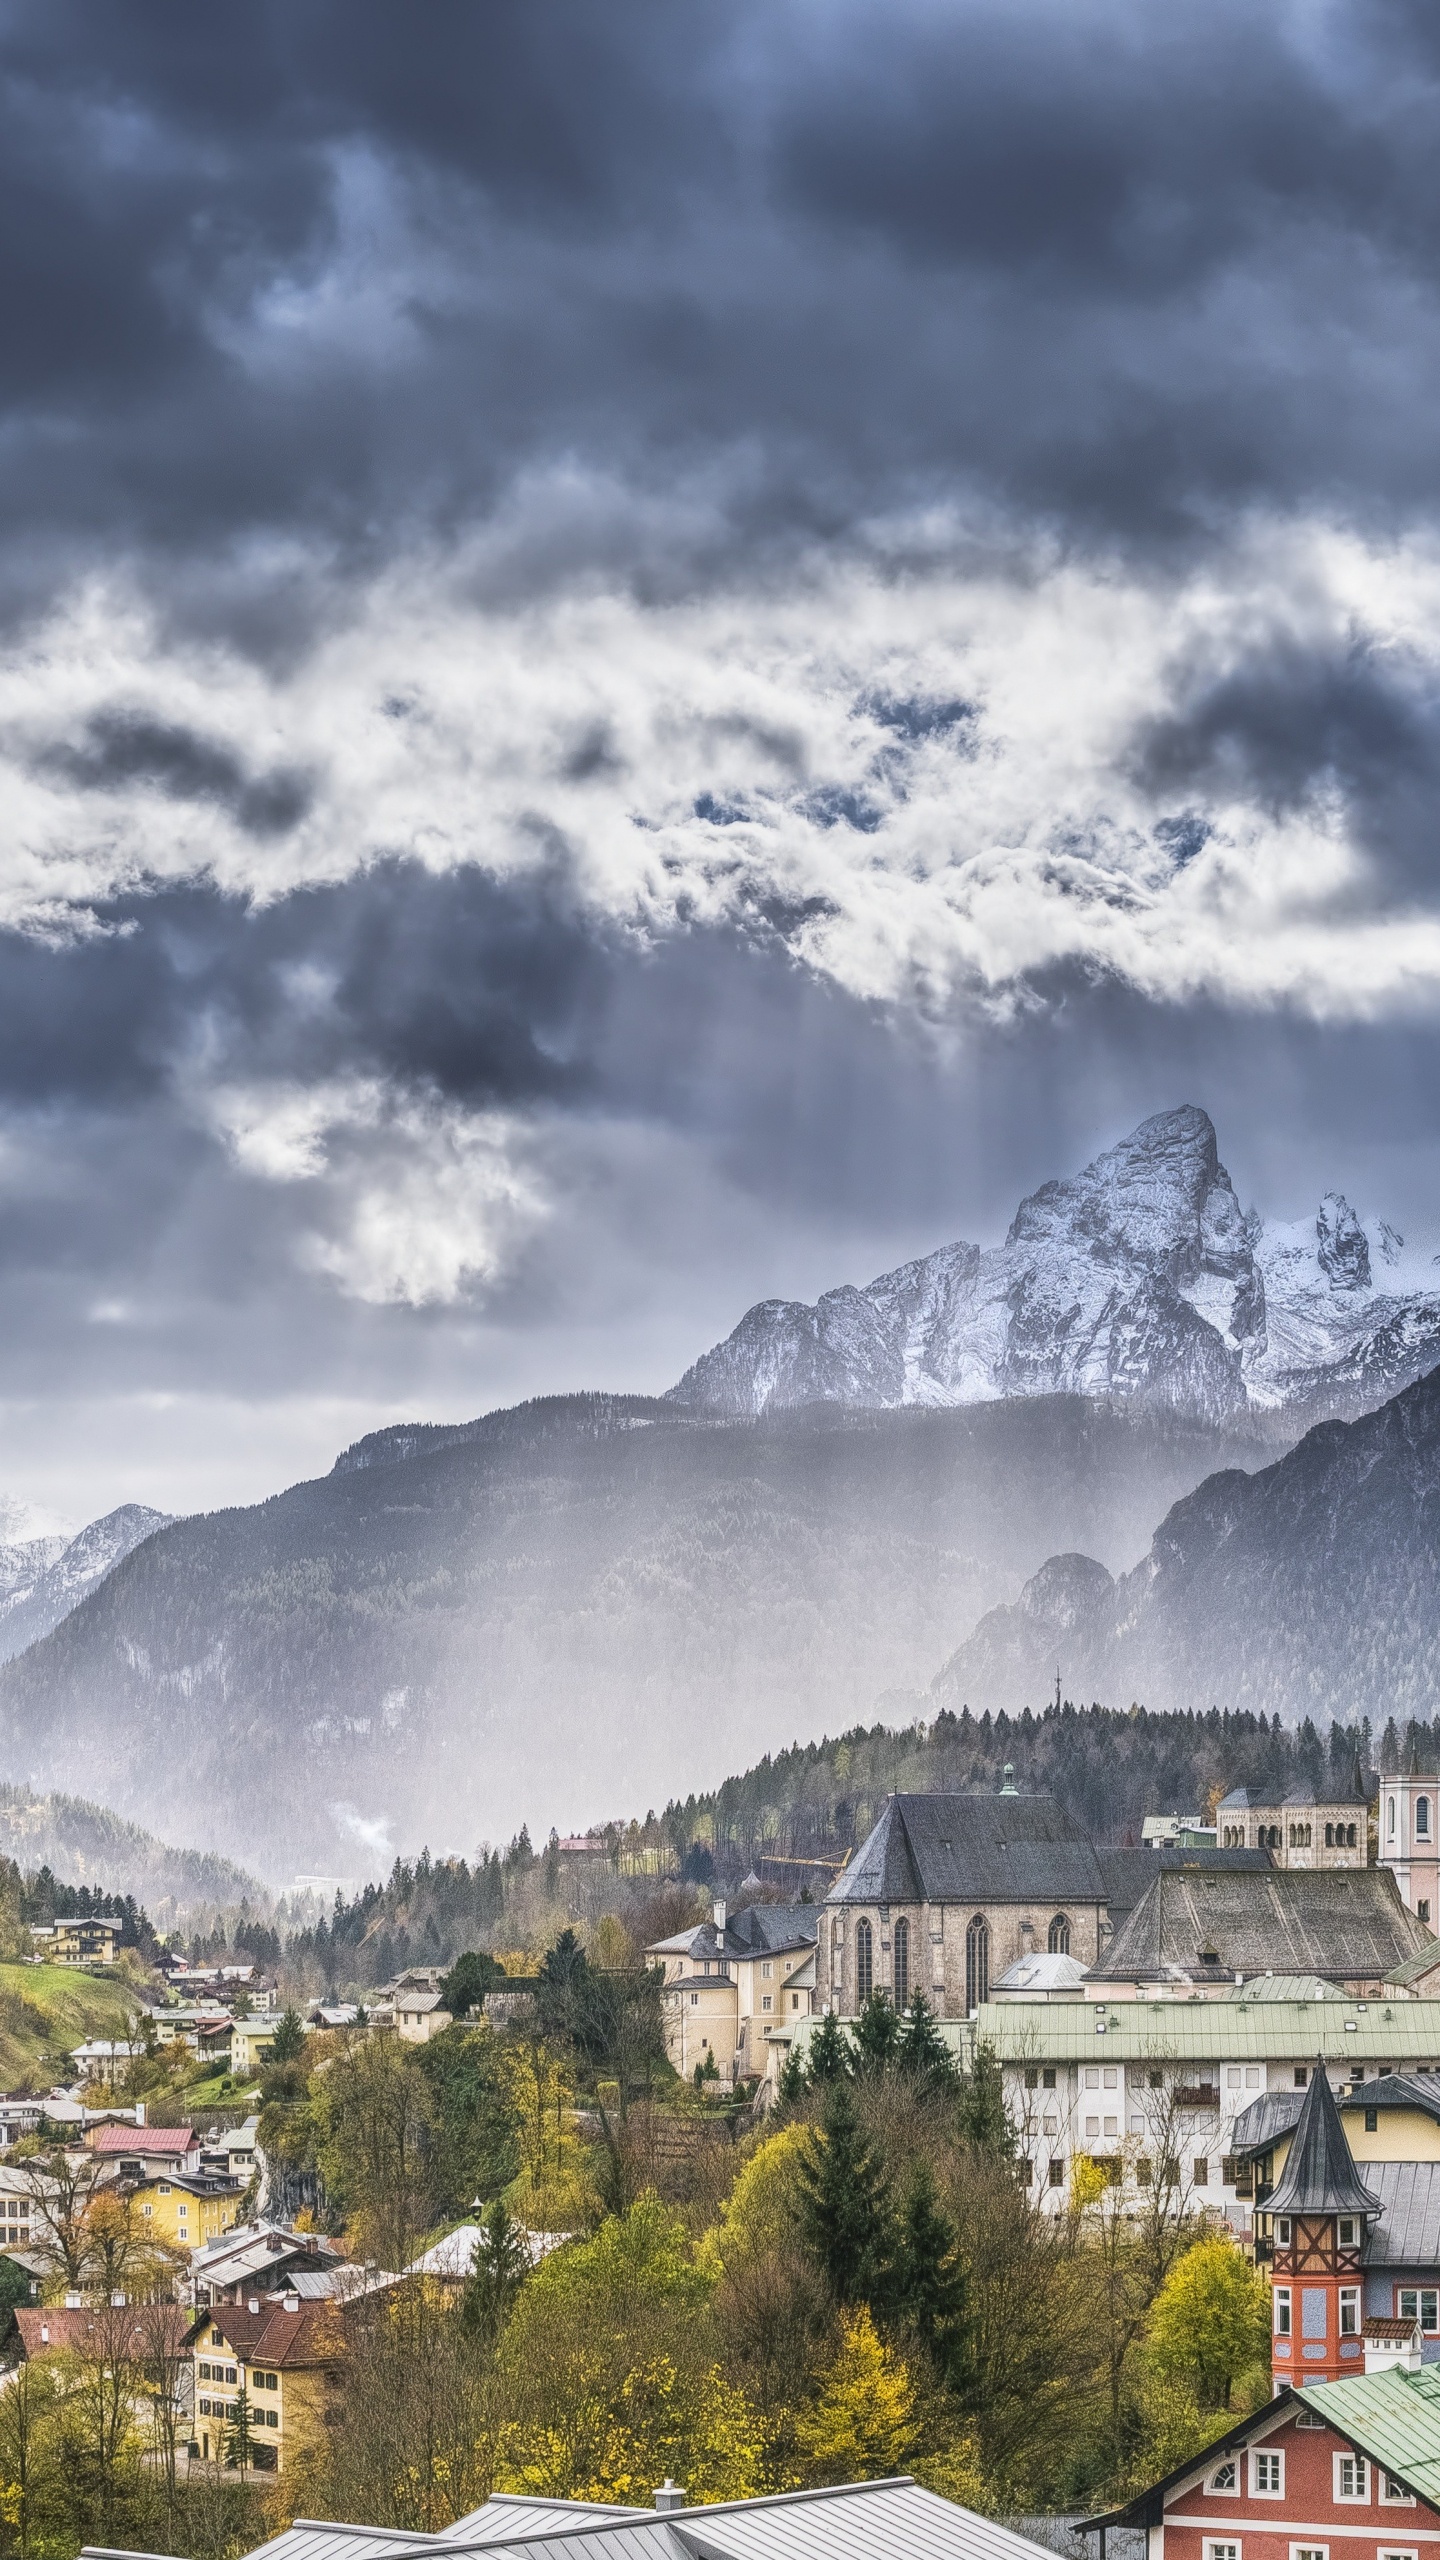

left=1092, top=1866, right=1425, bottom=1981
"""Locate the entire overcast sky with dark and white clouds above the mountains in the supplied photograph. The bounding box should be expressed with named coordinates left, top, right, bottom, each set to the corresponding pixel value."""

left=0, top=0, right=1440, bottom=1521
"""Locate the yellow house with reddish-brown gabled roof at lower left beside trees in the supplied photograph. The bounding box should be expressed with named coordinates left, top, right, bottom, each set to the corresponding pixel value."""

left=190, top=2294, right=343, bottom=2470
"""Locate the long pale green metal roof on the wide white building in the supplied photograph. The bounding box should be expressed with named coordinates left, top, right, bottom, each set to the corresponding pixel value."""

left=943, top=1999, right=1440, bottom=2068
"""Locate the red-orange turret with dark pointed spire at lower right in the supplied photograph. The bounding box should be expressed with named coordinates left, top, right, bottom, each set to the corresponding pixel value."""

left=1256, top=2061, right=1381, bottom=2388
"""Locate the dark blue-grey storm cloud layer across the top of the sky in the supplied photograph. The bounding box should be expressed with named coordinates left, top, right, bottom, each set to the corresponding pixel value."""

left=0, top=0, right=1440, bottom=578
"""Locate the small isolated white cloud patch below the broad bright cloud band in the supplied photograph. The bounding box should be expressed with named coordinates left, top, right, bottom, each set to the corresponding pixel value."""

left=202, top=1078, right=546, bottom=1306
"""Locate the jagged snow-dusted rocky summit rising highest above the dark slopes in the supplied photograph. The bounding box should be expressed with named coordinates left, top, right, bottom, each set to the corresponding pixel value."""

left=671, top=1103, right=1440, bottom=1421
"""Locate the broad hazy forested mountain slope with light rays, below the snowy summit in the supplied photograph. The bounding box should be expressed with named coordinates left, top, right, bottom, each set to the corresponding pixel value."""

left=0, top=1398, right=1266, bottom=1882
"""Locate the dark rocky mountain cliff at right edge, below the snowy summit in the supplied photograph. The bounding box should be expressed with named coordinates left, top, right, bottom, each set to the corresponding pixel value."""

left=933, top=1370, right=1440, bottom=1725
